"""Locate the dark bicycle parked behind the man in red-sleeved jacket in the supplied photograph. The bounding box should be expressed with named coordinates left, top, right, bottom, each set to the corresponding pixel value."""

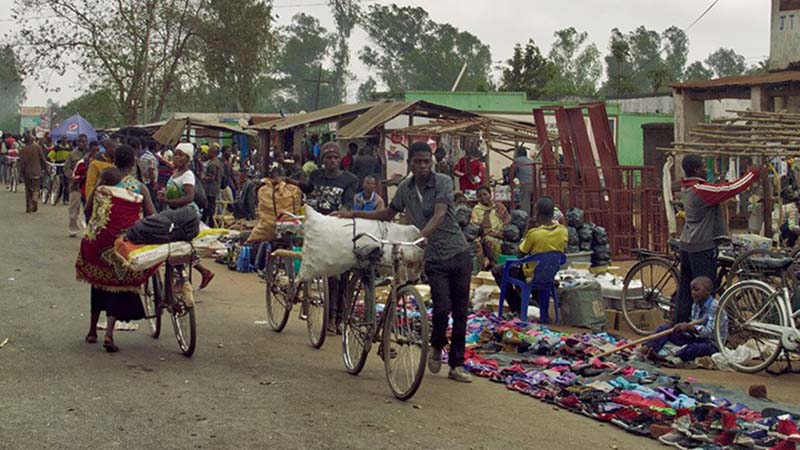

left=620, top=239, right=770, bottom=335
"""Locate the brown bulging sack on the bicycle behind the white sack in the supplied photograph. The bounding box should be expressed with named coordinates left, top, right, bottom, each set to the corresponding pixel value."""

left=247, top=178, right=303, bottom=242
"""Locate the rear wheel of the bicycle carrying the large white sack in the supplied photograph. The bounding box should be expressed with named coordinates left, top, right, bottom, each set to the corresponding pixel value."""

left=342, top=275, right=375, bottom=375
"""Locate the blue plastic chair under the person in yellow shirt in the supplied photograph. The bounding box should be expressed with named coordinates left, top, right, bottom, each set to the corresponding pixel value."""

left=497, top=252, right=567, bottom=323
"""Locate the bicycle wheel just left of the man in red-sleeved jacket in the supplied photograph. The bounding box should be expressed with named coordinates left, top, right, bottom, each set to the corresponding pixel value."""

left=621, top=257, right=680, bottom=334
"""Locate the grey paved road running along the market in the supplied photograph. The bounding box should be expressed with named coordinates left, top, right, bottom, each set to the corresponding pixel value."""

left=0, top=191, right=663, bottom=449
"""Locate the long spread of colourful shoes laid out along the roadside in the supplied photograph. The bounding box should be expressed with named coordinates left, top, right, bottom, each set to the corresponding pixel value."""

left=465, top=313, right=800, bottom=450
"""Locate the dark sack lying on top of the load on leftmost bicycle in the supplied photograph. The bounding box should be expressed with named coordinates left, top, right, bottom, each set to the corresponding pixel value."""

left=126, top=206, right=200, bottom=244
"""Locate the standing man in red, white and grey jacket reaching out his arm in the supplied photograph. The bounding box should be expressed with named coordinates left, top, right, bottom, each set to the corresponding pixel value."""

left=676, top=155, right=759, bottom=323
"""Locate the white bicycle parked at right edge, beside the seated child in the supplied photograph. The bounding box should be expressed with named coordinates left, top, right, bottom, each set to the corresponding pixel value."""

left=715, top=253, right=800, bottom=373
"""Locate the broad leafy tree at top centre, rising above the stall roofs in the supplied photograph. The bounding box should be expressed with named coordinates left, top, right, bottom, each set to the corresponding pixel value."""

left=359, top=4, right=492, bottom=92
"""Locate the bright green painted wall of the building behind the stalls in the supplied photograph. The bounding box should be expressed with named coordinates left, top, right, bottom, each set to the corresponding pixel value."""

left=405, top=91, right=674, bottom=166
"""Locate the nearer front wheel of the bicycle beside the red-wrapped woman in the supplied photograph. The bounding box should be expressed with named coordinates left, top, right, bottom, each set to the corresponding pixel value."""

left=165, top=267, right=197, bottom=357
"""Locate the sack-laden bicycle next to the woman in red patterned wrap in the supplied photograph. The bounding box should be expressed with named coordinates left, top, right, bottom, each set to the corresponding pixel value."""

left=143, top=252, right=197, bottom=358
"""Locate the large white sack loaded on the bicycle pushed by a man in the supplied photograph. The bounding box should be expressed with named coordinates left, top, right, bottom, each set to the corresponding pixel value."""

left=299, top=206, right=423, bottom=281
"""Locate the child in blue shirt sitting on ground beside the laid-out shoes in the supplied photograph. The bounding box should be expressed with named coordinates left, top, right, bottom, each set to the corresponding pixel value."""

left=642, top=277, right=728, bottom=365
